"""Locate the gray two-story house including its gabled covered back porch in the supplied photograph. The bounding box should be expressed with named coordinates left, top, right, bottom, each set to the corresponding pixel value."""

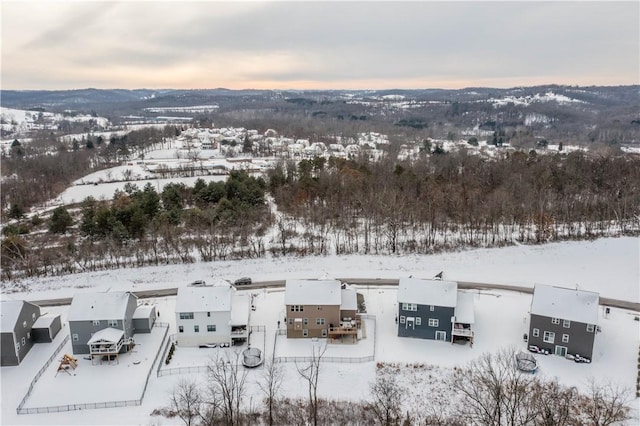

left=67, top=291, right=138, bottom=355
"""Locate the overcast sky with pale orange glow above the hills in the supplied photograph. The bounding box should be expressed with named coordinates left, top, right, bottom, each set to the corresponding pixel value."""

left=0, top=0, right=640, bottom=89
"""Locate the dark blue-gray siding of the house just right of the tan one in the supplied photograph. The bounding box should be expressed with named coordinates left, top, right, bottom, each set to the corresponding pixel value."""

left=398, top=303, right=454, bottom=340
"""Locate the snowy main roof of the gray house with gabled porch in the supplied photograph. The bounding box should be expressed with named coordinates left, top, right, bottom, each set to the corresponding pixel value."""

left=67, top=291, right=137, bottom=321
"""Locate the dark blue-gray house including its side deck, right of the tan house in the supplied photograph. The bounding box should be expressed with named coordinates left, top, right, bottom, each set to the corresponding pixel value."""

left=398, top=278, right=475, bottom=343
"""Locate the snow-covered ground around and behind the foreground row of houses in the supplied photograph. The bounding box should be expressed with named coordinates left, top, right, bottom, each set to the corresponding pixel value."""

left=0, top=238, right=640, bottom=425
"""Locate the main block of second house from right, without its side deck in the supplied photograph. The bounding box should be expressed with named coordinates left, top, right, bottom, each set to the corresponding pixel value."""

left=398, top=278, right=458, bottom=341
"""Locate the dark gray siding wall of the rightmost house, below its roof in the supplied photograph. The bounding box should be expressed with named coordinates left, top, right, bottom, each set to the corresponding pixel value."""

left=529, top=314, right=596, bottom=358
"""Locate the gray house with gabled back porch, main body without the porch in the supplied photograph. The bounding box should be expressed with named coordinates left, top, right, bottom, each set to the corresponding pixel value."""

left=68, top=291, right=138, bottom=354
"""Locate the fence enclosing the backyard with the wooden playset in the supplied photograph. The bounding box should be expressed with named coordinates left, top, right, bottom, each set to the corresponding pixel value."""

left=16, top=322, right=169, bottom=414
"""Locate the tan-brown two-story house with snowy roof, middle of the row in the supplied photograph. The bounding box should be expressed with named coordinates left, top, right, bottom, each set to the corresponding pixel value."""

left=285, top=280, right=358, bottom=338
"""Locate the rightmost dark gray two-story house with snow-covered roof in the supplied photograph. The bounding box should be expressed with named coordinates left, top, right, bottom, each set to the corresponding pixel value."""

left=529, top=284, right=600, bottom=358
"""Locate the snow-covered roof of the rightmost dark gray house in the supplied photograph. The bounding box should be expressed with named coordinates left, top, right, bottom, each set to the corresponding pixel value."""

left=531, top=284, right=600, bottom=324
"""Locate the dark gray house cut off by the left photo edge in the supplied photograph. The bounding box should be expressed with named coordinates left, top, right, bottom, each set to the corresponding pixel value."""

left=0, top=300, right=40, bottom=367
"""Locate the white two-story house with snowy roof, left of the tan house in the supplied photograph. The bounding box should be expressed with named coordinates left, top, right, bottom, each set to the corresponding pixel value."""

left=176, top=285, right=250, bottom=346
